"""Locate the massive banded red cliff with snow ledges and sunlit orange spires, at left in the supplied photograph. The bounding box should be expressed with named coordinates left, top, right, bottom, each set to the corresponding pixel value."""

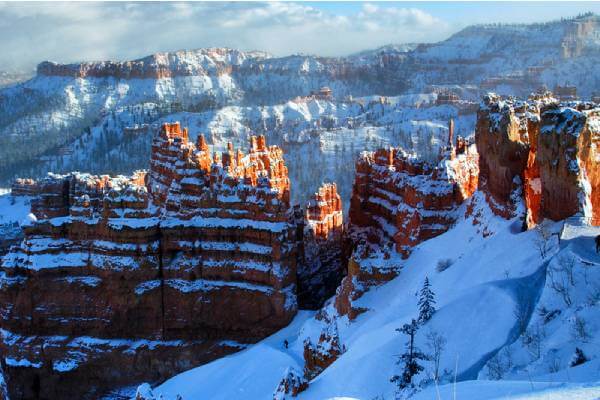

left=0, top=124, right=297, bottom=398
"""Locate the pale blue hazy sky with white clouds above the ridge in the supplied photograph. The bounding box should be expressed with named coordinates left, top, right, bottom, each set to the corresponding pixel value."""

left=0, top=2, right=600, bottom=70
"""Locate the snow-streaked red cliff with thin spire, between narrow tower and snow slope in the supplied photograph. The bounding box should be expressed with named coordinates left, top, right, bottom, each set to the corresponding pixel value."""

left=336, top=134, right=479, bottom=318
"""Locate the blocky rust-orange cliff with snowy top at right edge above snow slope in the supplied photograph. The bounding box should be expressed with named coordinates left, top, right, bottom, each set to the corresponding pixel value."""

left=475, top=95, right=600, bottom=227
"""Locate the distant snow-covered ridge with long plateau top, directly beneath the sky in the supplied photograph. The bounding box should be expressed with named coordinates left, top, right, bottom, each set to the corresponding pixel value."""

left=0, top=15, right=600, bottom=198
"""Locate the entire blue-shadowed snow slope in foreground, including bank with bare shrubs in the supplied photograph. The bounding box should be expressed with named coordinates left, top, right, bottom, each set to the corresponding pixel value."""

left=137, top=192, right=600, bottom=400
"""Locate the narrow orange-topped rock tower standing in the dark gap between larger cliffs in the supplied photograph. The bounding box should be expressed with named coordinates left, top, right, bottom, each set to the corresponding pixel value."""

left=298, top=184, right=346, bottom=309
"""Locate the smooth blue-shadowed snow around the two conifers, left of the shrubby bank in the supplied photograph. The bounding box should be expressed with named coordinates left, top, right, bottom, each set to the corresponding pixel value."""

left=143, top=193, right=580, bottom=399
